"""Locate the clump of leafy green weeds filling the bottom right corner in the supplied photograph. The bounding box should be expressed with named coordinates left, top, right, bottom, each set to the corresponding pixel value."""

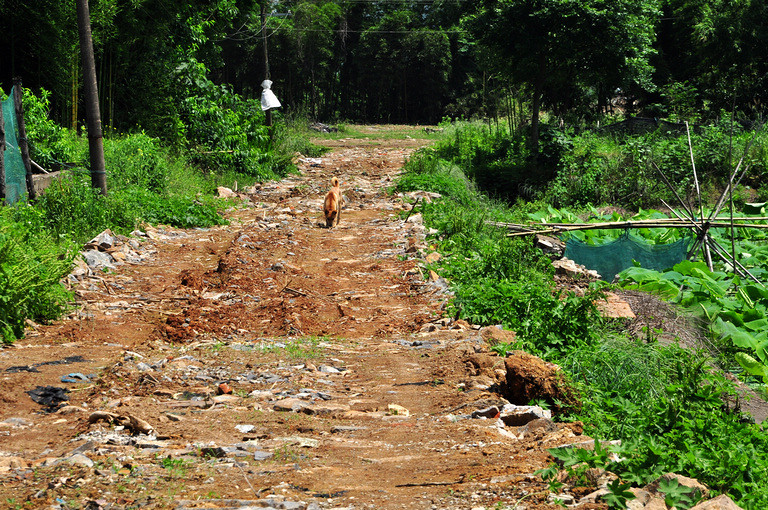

left=561, top=339, right=768, bottom=508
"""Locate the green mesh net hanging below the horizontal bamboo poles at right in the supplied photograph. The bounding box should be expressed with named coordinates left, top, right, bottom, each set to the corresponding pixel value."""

left=565, top=232, right=691, bottom=281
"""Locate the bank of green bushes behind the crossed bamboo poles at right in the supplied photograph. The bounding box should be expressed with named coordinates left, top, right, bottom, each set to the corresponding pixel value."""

left=543, top=120, right=768, bottom=209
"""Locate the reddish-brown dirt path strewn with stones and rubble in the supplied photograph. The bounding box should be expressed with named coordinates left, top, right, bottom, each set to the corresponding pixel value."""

left=0, top=129, right=601, bottom=510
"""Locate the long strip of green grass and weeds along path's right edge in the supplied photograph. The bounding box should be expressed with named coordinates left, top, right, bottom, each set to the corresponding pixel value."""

left=395, top=123, right=768, bottom=509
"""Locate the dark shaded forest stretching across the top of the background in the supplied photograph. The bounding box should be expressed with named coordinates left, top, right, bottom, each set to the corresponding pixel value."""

left=0, top=0, right=768, bottom=141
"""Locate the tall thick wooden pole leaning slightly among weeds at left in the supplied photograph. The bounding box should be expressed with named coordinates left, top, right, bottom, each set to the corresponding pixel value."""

left=77, top=0, right=107, bottom=195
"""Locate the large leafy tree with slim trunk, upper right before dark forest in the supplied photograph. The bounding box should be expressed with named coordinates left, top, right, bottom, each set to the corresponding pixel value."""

left=466, top=0, right=659, bottom=155
